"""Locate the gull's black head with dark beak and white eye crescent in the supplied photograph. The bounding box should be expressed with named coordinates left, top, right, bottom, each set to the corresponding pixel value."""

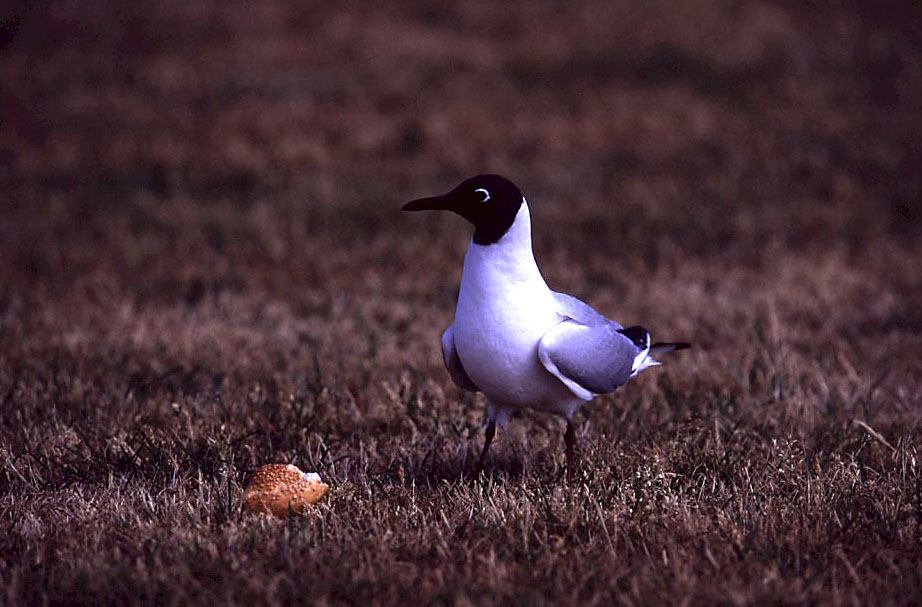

left=403, top=175, right=522, bottom=245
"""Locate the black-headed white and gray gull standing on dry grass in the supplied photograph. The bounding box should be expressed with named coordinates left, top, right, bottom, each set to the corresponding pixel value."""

left=403, top=175, right=689, bottom=482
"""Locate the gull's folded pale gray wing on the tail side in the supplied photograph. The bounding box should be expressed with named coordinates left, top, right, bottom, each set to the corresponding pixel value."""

left=538, top=320, right=641, bottom=400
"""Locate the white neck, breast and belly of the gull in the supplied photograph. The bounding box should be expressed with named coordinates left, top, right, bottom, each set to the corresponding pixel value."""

left=454, top=201, right=571, bottom=408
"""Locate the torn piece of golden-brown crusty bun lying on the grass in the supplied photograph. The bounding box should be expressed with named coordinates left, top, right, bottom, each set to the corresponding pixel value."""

left=244, top=464, right=329, bottom=518
